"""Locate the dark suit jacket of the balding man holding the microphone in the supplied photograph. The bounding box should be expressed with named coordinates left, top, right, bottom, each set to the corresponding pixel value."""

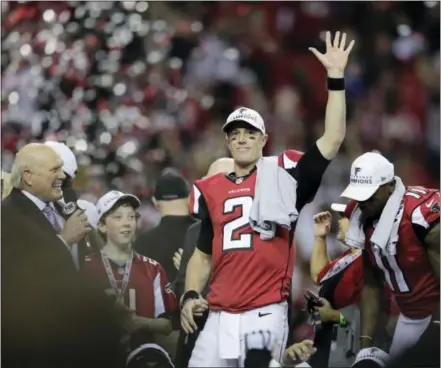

left=1, top=189, right=119, bottom=368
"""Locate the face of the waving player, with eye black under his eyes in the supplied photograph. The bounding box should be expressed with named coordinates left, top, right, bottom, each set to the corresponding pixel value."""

left=227, top=122, right=268, bottom=166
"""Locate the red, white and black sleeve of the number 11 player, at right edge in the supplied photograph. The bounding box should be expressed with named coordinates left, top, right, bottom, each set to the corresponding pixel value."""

left=406, top=188, right=440, bottom=242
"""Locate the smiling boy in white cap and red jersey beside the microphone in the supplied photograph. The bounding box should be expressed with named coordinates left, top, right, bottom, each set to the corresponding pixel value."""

left=86, top=190, right=177, bottom=356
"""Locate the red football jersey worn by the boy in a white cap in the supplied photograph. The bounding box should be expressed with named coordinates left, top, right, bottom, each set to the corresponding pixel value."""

left=85, top=253, right=178, bottom=318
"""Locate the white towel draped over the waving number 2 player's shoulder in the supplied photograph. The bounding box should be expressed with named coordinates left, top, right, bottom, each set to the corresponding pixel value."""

left=250, top=157, right=299, bottom=240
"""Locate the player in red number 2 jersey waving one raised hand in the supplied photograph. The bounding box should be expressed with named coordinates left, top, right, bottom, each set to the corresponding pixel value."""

left=181, top=32, right=354, bottom=367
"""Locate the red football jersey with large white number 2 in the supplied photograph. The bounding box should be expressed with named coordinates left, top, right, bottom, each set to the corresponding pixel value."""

left=190, top=149, right=329, bottom=313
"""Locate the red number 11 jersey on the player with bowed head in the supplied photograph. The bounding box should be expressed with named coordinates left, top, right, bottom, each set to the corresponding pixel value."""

left=366, top=187, right=440, bottom=319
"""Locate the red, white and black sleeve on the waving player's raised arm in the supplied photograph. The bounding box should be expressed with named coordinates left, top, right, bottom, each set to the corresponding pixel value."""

left=279, top=144, right=331, bottom=212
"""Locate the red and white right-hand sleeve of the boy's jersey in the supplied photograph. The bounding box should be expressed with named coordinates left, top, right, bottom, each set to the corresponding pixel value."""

left=153, top=261, right=178, bottom=318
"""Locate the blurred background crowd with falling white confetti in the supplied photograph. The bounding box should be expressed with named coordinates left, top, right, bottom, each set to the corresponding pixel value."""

left=1, top=1, right=440, bottom=302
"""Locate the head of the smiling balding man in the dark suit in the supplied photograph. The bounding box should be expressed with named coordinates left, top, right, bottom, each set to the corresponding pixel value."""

left=23, top=152, right=66, bottom=202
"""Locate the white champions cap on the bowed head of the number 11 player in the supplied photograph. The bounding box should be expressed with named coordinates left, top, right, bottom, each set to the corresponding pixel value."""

left=341, top=152, right=395, bottom=202
